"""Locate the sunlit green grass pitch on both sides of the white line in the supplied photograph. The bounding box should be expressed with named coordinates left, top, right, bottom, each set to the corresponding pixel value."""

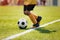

left=0, top=6, right=60, bottom=40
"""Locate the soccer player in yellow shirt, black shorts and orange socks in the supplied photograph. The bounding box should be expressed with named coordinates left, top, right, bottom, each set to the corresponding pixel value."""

left=24, top=0, right=42, bottom=28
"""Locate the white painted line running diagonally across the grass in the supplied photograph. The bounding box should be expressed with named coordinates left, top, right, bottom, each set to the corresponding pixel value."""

left=2, top=19, right=60, bottom=40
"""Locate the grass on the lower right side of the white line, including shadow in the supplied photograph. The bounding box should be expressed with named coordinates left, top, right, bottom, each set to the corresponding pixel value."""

left=14, top=22, right=60, bottom=40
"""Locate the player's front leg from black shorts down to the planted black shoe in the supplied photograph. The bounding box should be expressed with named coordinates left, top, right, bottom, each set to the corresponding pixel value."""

left=24, top=5, right=39, bottom=27
